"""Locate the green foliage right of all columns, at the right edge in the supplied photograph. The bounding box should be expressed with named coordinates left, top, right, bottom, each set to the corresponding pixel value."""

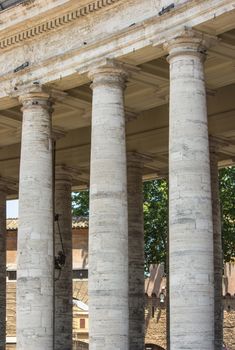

left=219, top=167, right=235, bottom=261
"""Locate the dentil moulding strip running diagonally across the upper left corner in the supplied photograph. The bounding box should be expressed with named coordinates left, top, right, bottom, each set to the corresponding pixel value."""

left=0, top=0, right=120, bottom=51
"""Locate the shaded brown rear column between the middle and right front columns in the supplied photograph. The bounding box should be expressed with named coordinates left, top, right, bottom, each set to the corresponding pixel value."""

left=127, top=153, right=145, bottom=350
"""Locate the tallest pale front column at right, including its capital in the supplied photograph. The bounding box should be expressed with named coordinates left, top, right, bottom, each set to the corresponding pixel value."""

left=168, top=30, right=214, bottom=350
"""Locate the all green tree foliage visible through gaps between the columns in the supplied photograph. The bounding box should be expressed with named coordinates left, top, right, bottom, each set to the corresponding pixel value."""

left=72, top=167, right=235, bottom=270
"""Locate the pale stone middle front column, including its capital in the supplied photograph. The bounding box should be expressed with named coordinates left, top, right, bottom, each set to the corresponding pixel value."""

left=88, top=62, right=129, bottom=350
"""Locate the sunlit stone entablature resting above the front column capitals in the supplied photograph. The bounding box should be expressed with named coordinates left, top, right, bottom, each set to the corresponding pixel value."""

left=0, top=0, right=235, bottom=109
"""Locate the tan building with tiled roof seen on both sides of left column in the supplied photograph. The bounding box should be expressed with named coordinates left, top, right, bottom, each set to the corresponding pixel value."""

left=6, top=218, right=89, bottom=350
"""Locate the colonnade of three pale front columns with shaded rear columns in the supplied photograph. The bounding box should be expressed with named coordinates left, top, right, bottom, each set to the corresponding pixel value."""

left=0, top=31, right=224, bottom=350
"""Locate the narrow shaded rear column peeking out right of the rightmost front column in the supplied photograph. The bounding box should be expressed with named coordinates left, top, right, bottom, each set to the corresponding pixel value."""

left=210, top=138, right=223, bottom=350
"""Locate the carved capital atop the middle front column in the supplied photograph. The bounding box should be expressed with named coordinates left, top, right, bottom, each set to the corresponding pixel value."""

left=88, top=59, right=129, bottom=88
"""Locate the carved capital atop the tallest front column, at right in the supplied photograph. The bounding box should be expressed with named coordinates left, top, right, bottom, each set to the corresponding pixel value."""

left=164, top=28, right=218, bottom=62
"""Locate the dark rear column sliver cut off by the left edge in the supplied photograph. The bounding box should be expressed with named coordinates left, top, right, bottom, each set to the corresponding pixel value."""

left=0, top=184, right=6, bottom=350
